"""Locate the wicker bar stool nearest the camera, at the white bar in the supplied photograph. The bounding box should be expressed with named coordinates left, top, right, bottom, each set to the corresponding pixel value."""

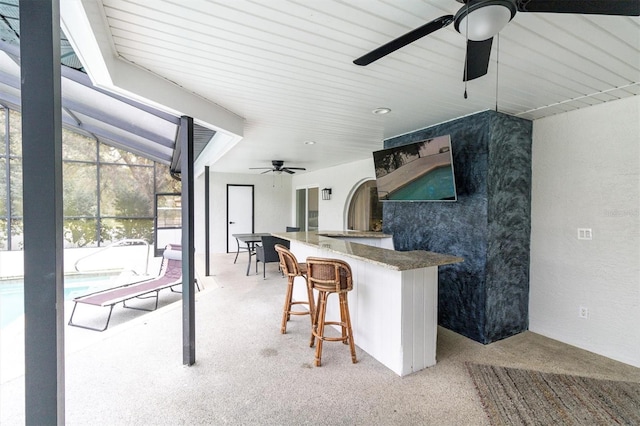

left=307, top=257, right=357, bottom=367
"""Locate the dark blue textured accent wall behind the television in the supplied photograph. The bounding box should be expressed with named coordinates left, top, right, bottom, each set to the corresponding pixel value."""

left=383, top=111, right=532, bottom=343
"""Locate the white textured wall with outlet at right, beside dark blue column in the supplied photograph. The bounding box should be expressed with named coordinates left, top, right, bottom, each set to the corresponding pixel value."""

left=529, top=96, right=640, bottom=367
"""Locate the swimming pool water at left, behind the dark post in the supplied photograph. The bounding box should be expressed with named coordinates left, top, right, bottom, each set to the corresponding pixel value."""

left=0, top=275, right=119, bottom=330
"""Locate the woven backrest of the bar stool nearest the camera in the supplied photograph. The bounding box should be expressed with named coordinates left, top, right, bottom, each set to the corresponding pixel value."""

left=307, top=257, right=353, bottom=293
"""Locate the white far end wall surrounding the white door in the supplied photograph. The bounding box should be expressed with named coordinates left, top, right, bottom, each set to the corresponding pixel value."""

left=194, top=173, right=293, bottom=253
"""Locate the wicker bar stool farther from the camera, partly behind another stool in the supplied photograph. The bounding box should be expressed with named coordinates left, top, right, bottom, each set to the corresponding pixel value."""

left=275, top=244, right=315, bottom=334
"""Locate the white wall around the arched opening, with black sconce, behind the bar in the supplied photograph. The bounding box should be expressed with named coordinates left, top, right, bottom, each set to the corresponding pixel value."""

left=291, top=158, right=375, bottom=230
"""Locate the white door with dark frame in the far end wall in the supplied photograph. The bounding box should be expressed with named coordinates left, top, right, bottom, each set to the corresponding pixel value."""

left=227, top=185, right=254, bottom=253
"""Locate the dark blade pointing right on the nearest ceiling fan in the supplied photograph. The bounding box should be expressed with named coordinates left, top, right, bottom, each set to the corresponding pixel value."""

left=517, top=0, right=640, bottom=16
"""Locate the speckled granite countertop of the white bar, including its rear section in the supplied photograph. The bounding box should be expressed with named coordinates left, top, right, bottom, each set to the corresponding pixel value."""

left=272, top=231, right=464, bottom=271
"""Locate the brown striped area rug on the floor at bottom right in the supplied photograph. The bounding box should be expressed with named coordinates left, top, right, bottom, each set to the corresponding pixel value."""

left=467, top=363, right=640, bottom=426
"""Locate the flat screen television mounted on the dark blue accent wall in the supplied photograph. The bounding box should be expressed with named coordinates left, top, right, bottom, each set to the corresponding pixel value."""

left=373, top=135, right=457, bottom=201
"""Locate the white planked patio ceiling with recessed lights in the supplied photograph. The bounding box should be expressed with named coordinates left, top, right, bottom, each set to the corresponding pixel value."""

left=66, top=0, right=640, bottom=173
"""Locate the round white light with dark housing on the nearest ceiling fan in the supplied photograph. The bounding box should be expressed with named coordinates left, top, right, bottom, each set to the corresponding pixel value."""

left=455, top=0, right=516, bottom=41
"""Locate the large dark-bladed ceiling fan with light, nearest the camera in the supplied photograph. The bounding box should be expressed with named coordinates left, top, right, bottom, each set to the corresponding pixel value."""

left=353, top=0, right=640, bottom=81
